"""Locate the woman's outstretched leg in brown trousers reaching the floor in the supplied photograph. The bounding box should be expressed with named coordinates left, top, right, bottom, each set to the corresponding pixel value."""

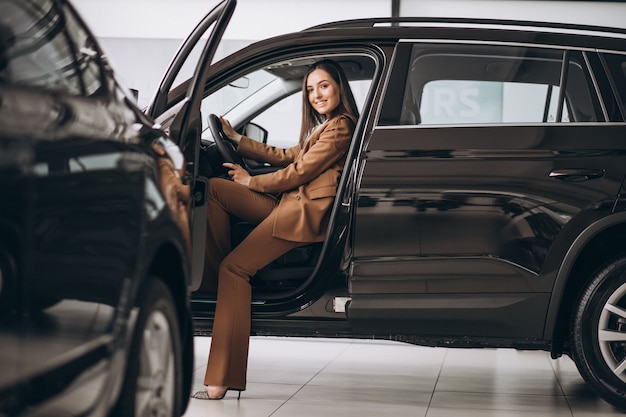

left=204, top=210, right=303, bottom=390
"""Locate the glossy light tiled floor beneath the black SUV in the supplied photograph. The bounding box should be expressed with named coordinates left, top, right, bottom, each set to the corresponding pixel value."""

left=185, top=337, right=626, bottom=417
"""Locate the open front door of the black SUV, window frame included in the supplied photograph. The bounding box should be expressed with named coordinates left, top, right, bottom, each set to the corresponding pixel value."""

left=146, top=0, right=237, bottom=291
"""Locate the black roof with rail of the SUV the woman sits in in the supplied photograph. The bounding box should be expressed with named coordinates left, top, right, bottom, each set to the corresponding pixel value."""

left=185, top=17, right=626, bottom=109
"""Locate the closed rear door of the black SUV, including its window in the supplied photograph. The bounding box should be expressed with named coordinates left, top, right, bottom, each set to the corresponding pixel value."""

left=348, top=42, right=626, bottom=338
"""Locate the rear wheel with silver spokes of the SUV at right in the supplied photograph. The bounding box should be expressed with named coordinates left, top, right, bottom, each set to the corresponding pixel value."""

left=571, top=257, right=626, bottom=408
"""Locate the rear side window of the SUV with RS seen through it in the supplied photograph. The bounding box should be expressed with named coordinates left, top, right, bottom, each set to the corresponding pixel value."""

left=381, top=44, right=603, bottom=125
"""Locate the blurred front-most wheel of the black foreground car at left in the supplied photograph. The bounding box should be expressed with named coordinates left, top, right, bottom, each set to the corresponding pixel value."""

left=111, top=279, right=182, bottom=417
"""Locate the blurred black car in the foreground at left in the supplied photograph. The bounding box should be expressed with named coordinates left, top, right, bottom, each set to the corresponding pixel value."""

left=0, top=0, right=199, bottom=417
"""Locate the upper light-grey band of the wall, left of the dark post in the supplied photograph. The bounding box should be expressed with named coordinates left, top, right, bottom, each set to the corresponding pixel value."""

left=72, top=0, right=391, bottom=40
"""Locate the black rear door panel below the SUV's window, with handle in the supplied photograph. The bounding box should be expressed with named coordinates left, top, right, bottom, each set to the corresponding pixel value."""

left=349, top=124, right=626, bottom=338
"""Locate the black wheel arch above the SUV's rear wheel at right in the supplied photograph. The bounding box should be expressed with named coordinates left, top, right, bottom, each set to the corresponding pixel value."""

left=544, top=212, right=626, bottom=358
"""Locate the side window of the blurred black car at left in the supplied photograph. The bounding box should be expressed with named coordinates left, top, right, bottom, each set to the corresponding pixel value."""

left=0, top=2, right=101, bottom=95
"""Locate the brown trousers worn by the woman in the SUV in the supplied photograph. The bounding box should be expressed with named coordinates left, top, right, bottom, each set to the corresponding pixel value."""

left=204, top=178, right=304, bottom=390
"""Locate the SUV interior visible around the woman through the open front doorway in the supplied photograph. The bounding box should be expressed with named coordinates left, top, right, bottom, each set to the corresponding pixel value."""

left=196, top=54, right=375, bottom=299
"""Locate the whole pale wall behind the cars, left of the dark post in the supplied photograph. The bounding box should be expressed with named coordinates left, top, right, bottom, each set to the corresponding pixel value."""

left=72, top=0, right=391, bottom=106
